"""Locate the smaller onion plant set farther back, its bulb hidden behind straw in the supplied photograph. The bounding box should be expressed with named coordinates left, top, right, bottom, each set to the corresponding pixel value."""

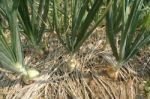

left=18, top=0, right=50, bottom=52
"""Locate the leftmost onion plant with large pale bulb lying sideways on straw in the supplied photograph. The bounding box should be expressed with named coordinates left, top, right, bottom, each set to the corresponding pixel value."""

left=0, top=0, right=39, bottom=79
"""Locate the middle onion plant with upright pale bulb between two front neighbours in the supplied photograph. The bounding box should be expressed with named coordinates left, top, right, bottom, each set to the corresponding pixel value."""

left=52, top=0, right=112, bottom=71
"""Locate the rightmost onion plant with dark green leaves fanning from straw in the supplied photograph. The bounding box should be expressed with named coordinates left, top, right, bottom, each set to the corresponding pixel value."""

left=106, top=0, right=150, bottom=75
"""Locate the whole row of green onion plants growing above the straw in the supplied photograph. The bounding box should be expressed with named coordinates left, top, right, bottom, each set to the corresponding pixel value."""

left=0, top=0, right=150, bottom=79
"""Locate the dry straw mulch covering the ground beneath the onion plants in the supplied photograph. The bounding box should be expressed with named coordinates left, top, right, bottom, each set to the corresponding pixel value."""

left=0, top=28, right=150, bottom=99
